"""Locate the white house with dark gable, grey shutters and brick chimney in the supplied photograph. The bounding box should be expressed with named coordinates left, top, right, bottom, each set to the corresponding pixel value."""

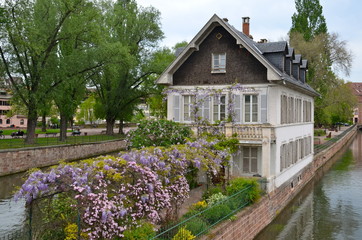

left=157, top=15, right=319, bottom=192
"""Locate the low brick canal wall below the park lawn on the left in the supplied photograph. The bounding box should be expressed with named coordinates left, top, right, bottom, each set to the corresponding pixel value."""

left=0, top=140, right=126, bottom=176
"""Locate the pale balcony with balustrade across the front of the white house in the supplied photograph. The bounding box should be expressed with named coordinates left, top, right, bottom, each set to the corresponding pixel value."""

left=190, top=123, right=275, bottom=143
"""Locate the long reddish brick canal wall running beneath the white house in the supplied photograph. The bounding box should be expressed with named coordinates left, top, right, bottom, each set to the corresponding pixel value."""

left=203, top=126, right=357, bottom=240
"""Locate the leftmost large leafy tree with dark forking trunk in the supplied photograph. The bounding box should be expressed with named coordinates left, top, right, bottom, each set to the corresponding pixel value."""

left=0, top=0, right=96, bottom=143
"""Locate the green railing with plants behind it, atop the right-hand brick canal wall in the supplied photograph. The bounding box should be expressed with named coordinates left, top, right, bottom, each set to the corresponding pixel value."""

left=151, top=186, right=251, bottom=240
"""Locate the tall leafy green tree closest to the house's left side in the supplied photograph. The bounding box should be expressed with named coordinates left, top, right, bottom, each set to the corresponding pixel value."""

left=91, top=0, right=163, bottom=134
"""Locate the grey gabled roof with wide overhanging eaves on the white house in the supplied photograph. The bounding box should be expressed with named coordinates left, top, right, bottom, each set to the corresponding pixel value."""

left=156, top=14, right=319, bottom=96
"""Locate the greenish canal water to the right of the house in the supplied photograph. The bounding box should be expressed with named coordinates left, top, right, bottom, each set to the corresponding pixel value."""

left=254, top=132, right=362, bottom=240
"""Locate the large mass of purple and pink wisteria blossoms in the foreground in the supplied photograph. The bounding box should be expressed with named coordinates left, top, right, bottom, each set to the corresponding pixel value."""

left=15, top=139, right=228, bottom=239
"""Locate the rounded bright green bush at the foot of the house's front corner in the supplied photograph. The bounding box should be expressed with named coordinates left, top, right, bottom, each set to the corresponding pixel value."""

left=226, top=178, right=261, bottom=203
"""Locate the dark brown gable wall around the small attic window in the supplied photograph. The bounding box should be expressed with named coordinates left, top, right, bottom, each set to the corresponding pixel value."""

left=173, top=26, right=267, bottom=85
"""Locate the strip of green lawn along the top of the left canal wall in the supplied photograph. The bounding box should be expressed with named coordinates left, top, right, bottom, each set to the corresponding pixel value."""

left=0, top=133, right=123, bottom=149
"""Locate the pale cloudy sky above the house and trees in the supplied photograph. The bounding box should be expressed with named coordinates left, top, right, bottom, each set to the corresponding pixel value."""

left=137, top=0, right=362, bottom=82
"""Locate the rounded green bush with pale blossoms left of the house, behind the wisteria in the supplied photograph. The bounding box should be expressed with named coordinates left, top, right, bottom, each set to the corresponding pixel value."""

left=129, top=120, right=191, bottom=149
